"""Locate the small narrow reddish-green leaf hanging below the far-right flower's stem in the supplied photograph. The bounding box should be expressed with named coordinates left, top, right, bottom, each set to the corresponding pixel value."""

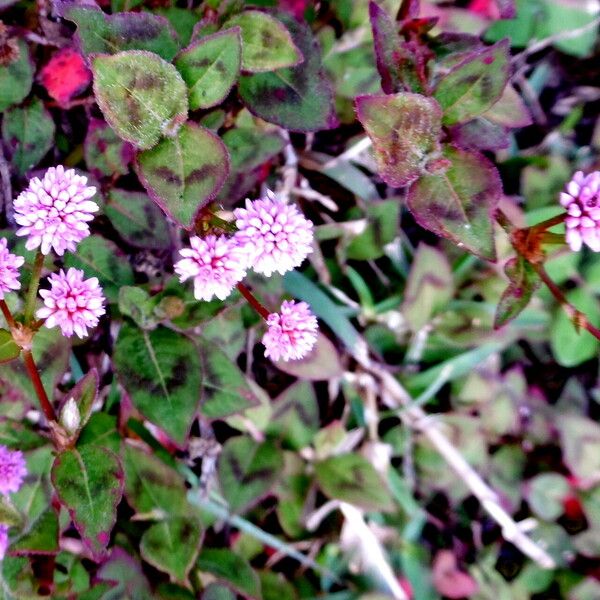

left=494, top=257, right=541, bottom=329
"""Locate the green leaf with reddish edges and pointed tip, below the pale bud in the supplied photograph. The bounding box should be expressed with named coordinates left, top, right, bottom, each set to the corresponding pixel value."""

left=52, top=445, right=123, bottom=559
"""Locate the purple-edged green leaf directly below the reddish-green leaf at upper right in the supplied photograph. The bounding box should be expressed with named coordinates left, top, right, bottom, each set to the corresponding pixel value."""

left=408, top=146, right=502, bottom=260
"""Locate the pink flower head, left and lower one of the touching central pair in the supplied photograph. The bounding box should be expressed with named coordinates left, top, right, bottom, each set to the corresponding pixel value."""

left=175, top=235, right=248, bottom=300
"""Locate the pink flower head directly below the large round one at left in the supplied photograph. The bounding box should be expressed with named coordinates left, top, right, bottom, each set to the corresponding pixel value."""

left=36, top=267, right=106, bottom=338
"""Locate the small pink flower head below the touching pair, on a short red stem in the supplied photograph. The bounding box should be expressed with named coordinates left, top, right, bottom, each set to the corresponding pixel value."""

left=262, top=300, right=318, bottom=361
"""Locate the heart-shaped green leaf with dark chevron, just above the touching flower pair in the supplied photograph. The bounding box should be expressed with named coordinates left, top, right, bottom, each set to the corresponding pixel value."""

left=138, top=122, right=229, bottom=228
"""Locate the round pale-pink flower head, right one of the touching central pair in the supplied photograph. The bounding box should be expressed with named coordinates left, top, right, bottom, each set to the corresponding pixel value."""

left=233, top=192, right=313, bottom=277
